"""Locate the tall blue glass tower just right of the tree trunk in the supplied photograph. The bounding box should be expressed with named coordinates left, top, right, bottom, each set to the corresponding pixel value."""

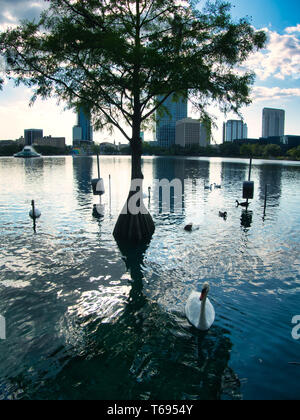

left=156, top=95, right=187, bottom=147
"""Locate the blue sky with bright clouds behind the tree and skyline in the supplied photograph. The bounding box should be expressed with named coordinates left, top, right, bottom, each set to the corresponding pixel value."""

left=0, top=0, right=300, bottom=144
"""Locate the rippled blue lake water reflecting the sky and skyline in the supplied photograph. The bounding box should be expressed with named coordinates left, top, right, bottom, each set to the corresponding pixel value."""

left=0, top=157, right=300, bottom=400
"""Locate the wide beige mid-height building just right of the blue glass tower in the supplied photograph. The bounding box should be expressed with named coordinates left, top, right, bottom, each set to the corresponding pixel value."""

left=175, top=118, right=210, bottom=147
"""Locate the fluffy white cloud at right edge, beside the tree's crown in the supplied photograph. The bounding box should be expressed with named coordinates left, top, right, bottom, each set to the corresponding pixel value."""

left=246, top=25, right=300, bottom=80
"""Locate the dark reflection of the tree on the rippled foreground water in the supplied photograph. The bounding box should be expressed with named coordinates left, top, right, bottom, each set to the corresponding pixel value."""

left=0, top=240, right=241, bottom=400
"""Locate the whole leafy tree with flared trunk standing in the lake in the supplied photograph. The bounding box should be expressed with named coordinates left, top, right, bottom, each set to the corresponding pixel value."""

left=0, top=0, right=266, bottom=241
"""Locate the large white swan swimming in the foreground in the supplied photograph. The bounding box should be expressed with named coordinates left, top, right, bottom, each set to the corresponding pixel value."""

left=185, top=283, right=216, bottom=331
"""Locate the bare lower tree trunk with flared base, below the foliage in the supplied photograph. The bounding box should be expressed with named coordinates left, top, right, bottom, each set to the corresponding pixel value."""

left=113, top=132, right=155, bottom=244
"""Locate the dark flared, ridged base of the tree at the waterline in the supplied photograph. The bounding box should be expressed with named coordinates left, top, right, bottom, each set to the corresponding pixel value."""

left=113, top=204, right=155, bottom=244
